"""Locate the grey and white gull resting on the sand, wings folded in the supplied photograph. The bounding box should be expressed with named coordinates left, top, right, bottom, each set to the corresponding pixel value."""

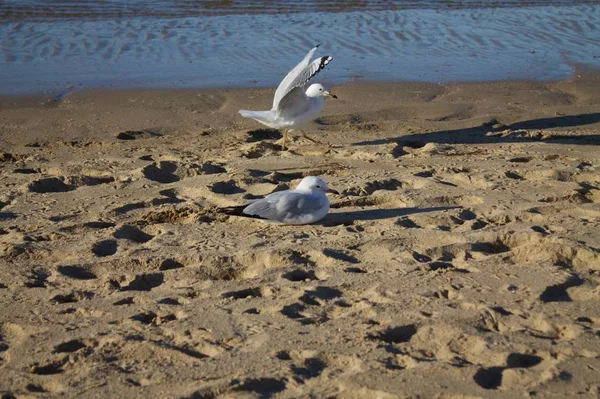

left=217, top=176, right=339, bottom=224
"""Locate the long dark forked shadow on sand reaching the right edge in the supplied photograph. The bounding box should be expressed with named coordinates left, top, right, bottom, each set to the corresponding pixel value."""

left=354, top=113, right=600, bottom=148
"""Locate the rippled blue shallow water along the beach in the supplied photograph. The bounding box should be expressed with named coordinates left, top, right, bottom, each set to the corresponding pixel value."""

left=0, top=0, right=600, bottom=95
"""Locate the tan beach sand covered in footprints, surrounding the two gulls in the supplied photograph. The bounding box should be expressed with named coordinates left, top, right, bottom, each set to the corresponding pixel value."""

left=0, top=70, right=600, bottom=398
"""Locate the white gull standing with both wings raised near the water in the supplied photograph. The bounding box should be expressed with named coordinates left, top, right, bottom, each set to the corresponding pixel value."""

left=240, top=44, right=337, bottom=150
